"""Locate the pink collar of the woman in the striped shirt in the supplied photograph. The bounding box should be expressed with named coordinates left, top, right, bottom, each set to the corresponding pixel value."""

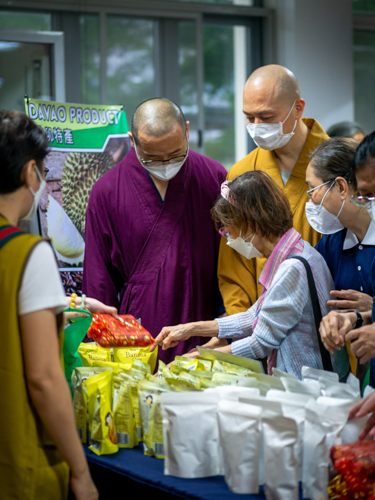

left=259, top=227, right=303, bottom=290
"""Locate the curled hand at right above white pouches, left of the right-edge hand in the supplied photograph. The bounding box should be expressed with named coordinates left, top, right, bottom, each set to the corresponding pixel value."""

left=319, top=311, right=354, bottom=354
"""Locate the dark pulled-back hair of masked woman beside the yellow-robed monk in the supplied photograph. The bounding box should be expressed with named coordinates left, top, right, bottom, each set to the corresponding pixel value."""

left=310, top=137, right=358, bottom=190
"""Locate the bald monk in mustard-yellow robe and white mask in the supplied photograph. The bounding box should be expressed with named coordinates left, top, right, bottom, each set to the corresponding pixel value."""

left=218, top=64, right=328, bottom=320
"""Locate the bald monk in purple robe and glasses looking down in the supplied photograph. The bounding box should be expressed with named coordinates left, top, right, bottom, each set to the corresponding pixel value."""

left=83, top=98, right=227, bottom=362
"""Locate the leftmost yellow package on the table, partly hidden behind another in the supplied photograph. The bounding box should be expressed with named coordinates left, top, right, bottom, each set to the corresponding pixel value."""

left=72, top=367, right=110, bottom=443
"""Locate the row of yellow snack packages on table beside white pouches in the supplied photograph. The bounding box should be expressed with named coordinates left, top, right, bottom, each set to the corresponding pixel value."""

left=72, top=344, right=284, bottom=458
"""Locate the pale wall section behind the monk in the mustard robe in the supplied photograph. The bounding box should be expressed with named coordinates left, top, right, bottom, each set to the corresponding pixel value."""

left=265, top=0, right=354, bottom=128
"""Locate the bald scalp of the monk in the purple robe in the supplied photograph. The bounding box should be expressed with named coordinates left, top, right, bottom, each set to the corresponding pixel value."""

left=132, top=97, right=186, bottom=143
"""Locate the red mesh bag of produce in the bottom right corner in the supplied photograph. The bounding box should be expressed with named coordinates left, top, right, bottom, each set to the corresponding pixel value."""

left=329, top=439, right=375, bottom=500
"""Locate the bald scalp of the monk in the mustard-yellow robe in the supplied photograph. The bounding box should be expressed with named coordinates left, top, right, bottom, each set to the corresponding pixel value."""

left=245, top=64, right=301, bottom=107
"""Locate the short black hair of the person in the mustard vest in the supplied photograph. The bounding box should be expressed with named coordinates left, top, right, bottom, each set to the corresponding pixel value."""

left=0, top=110, right=48, bottom=194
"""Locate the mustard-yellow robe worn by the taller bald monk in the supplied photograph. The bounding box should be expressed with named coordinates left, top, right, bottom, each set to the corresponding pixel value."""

left=218, top=118, right=329, bottom=315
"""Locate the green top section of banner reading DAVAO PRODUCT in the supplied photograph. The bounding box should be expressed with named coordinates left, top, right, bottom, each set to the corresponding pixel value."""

left=25, top=97, right=129, bottom=153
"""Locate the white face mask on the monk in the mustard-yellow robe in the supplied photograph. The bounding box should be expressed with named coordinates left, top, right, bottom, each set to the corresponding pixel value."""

left=246, top=101, right=297, bottom=151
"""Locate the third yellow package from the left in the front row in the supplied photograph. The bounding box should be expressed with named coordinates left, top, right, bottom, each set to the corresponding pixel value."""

left=112, top=373, right=138, bottom=448
